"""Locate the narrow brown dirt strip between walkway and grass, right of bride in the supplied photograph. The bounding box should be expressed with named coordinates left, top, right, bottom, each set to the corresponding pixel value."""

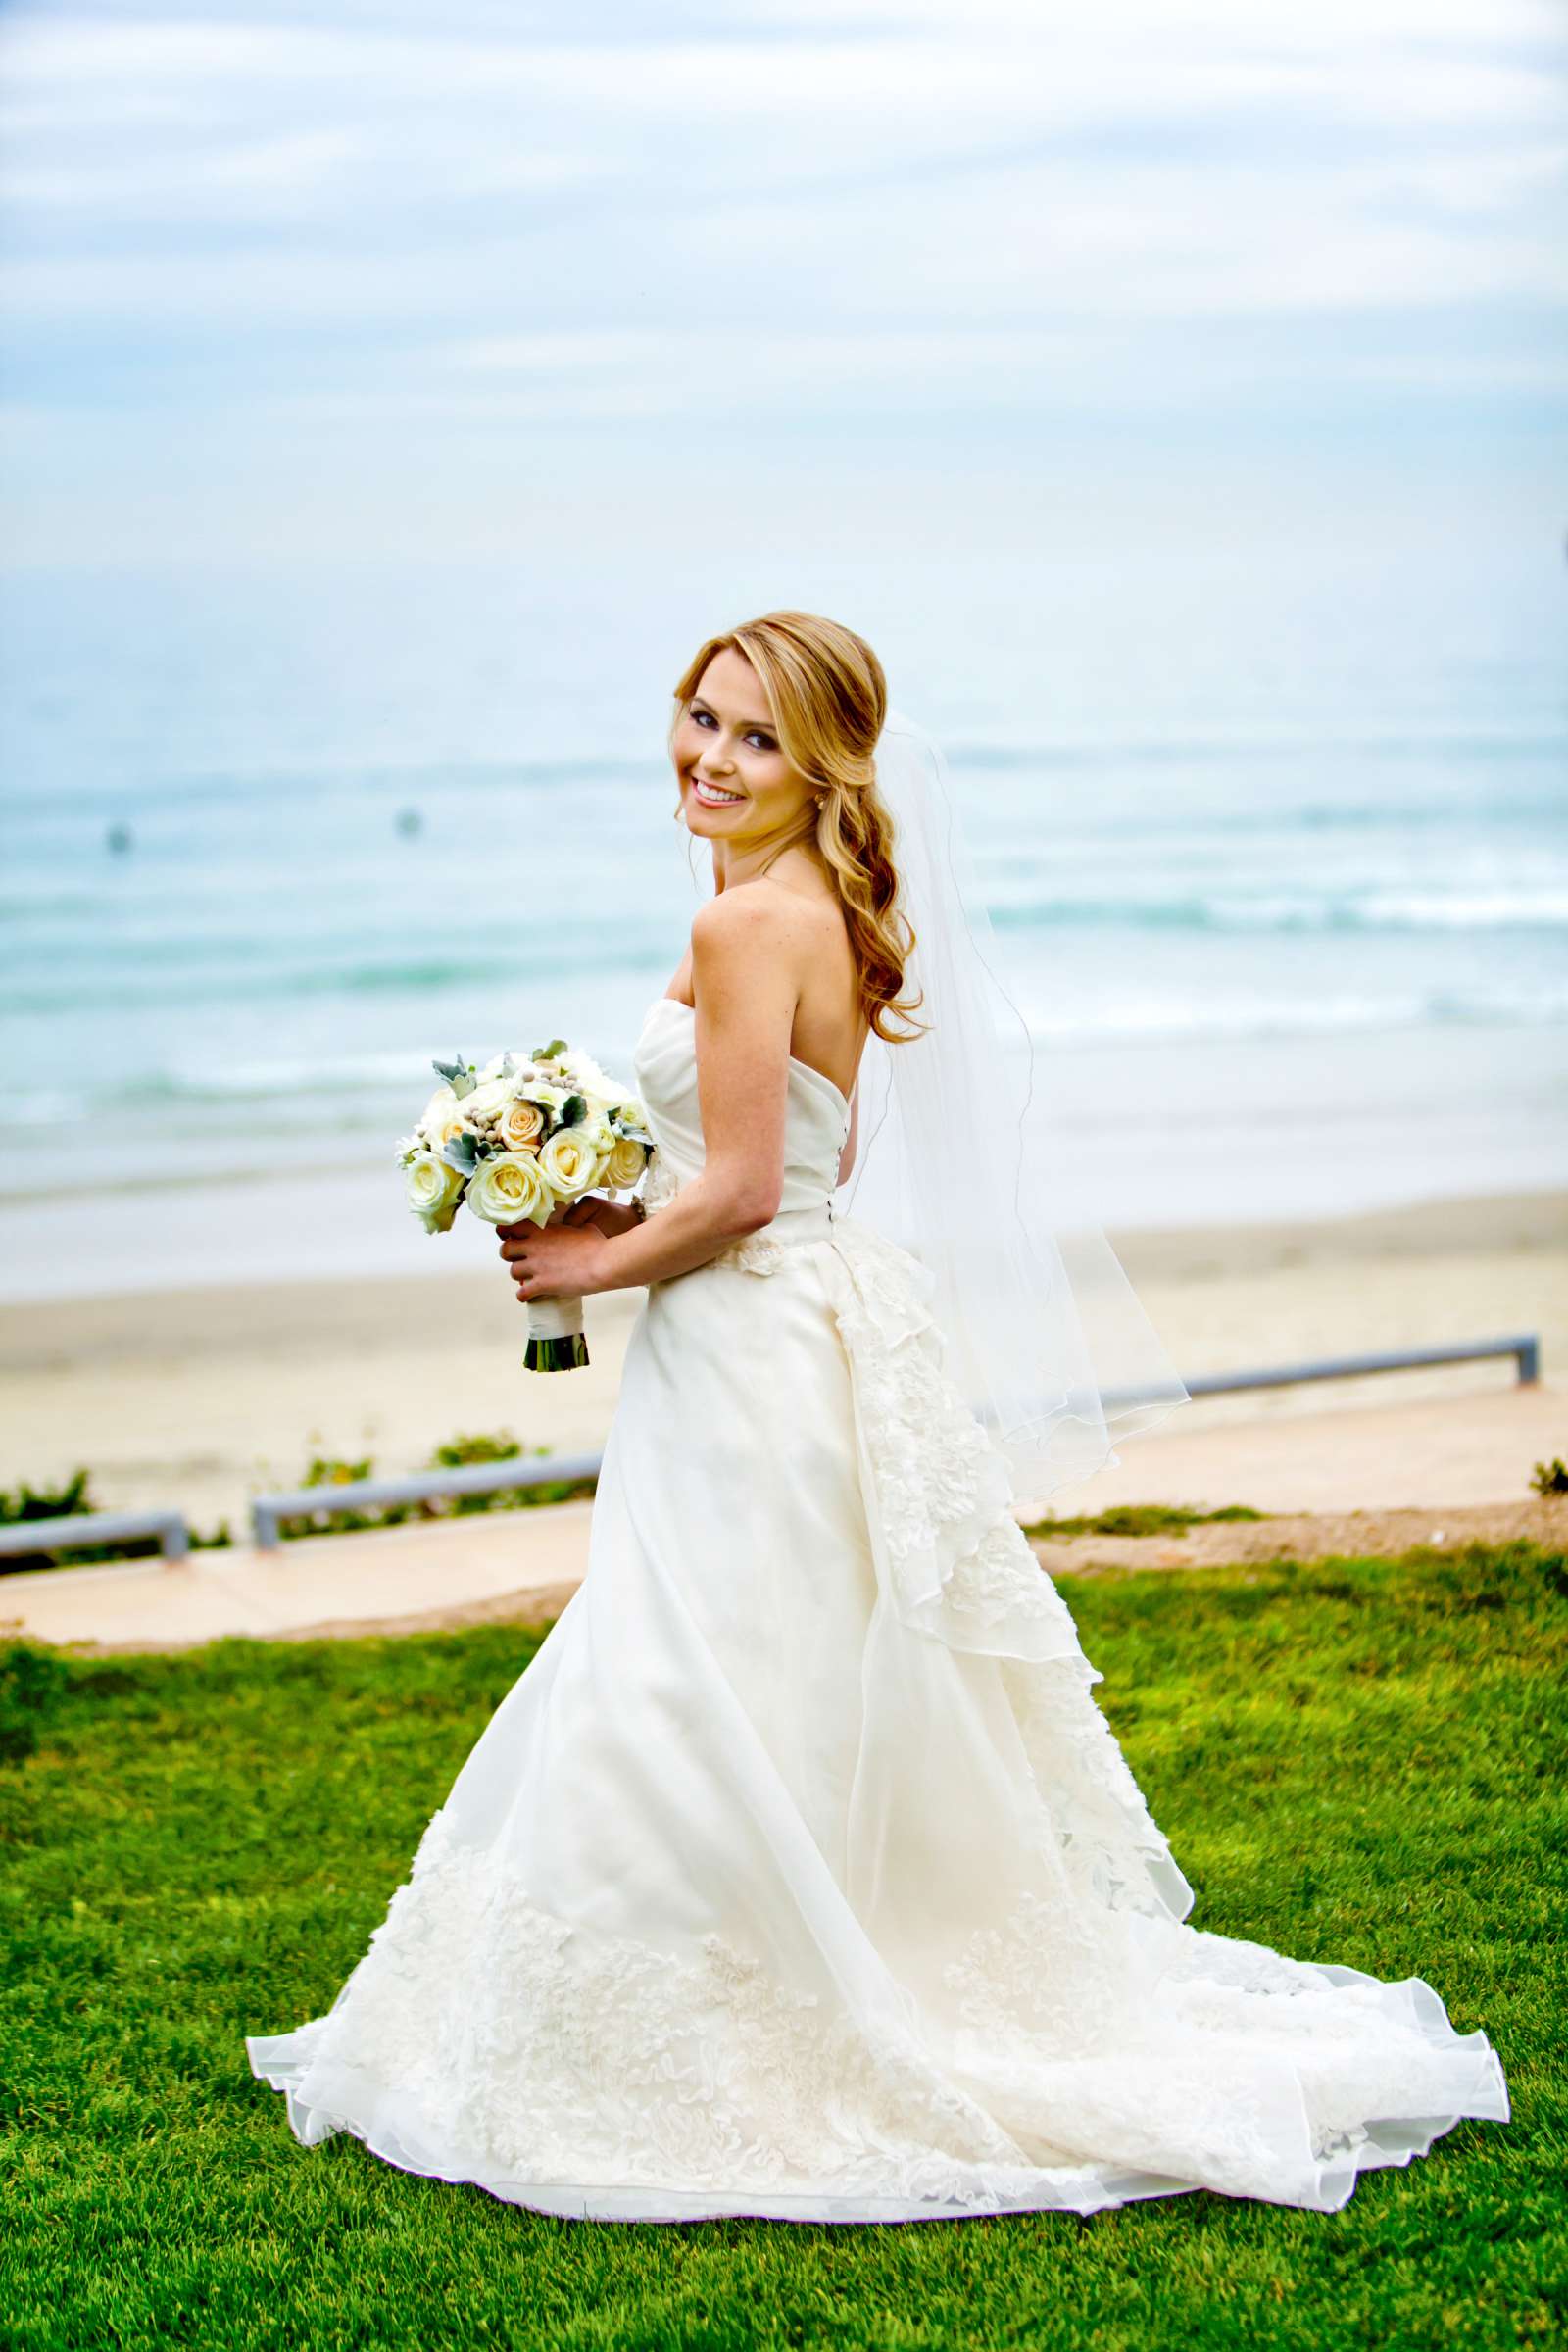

left=1030, top=1498, right=1568, bottom=1576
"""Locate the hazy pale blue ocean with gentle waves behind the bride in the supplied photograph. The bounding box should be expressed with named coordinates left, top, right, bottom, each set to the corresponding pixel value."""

left=0, top=555, right=1568, bottom=1298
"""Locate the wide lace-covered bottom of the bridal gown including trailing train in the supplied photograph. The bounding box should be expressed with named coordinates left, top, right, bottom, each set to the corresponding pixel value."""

left=259, top=1809, right=1507, bottom=2216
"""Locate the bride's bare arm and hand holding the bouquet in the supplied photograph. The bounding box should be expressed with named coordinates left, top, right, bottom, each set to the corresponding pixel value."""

left=501, top=882, right=808, bottom=1300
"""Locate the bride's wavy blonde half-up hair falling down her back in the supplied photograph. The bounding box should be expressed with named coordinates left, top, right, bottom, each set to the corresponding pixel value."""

left=670, top=612, right=924, bottom=1045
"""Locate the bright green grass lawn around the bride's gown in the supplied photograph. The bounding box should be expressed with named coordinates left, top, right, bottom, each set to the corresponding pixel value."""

left=0, top=1545, right=1568, bottom=2352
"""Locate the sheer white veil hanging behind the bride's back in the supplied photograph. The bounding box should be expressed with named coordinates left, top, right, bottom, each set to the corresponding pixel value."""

left=839, top=710, right=1187, bottom=1505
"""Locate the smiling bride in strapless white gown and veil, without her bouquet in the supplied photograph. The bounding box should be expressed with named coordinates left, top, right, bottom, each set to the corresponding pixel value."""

left=247, top=612, right=1509, bottom=2221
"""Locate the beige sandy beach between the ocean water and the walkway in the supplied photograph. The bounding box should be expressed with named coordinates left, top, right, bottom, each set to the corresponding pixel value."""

left=0, top=1193, right=1568, bottom=1536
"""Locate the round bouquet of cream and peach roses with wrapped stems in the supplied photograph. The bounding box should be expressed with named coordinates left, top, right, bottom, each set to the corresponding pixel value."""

left=397, top=1037, right=654, bottom=1371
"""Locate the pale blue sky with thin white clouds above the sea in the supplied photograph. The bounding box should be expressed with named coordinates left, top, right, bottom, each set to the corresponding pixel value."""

left=0, top=0, right=1568, bottom=569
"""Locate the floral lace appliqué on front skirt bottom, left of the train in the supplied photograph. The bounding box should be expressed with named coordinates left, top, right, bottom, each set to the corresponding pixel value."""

left=291, top=1809, right=1067, bottom=2206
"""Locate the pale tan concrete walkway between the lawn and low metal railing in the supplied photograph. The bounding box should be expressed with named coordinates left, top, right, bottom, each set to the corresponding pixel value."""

left=0, top=1388, right=1568, bottom=1648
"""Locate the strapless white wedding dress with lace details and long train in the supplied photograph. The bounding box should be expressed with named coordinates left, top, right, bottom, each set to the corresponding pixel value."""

left=247, top=998, right=1509, bottom=2221
